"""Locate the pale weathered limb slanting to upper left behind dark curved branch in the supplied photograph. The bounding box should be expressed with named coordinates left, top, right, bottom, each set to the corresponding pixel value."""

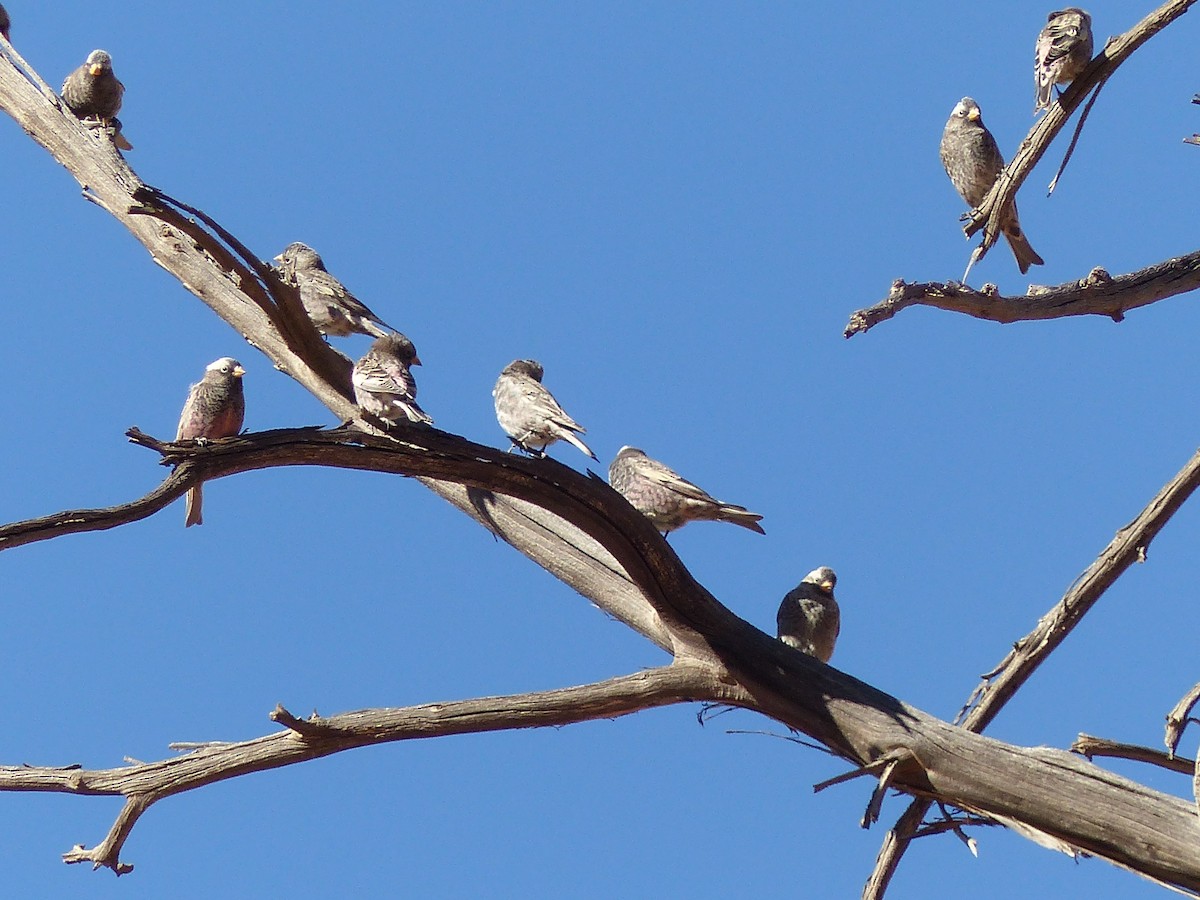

left=0, top=43, right=686, bottom=681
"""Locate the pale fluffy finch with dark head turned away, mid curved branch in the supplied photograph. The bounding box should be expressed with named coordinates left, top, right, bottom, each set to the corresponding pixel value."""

left=492, top=359, right=599, bottom=462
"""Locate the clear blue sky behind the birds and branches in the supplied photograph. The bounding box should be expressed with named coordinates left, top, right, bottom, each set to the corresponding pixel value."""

left=0, top=0, right=1200, bottom=900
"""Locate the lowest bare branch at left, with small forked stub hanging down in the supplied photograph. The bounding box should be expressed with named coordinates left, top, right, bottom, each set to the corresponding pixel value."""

left=23, top=664, right=715, bottom=875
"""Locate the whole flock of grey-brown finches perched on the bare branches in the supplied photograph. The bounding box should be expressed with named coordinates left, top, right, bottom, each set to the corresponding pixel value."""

left=0, top=6, right=1092, bottom=662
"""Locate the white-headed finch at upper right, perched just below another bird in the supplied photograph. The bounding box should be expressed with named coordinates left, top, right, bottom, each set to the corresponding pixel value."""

left=941, top=97, right=1045, bottom=281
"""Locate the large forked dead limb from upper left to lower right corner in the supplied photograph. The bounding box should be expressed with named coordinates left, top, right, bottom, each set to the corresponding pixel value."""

left=7, top=14, right=1200, bottom=889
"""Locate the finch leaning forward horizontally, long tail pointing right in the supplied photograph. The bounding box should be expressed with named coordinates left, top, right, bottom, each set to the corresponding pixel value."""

left=608, top=446, right=766, bottom=535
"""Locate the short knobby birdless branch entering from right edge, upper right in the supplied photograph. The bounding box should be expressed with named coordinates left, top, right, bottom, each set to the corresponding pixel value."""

left=842, top=251, right=1200, bottom=337
